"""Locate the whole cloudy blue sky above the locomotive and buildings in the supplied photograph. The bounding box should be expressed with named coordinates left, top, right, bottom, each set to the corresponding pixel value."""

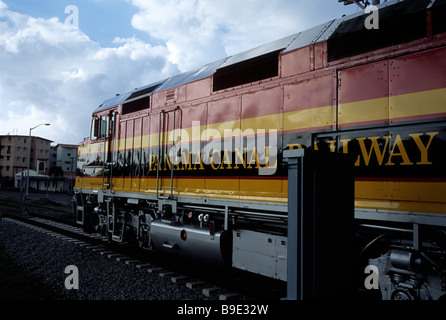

left=0, top=0, right=359, bottom=145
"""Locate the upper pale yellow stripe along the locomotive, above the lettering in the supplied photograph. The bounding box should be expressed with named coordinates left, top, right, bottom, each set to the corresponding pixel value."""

left=80, top=88, right=446, bottom=154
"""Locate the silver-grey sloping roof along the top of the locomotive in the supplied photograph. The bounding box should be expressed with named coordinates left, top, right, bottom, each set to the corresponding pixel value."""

left=96, top=0, right=436, bottom=111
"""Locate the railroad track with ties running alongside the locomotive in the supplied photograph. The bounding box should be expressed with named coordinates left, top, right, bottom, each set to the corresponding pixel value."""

left=0, top=214, right=284, bottom=300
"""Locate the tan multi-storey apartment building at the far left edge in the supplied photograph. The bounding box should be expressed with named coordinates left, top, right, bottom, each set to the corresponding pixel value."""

left=0, top=135, right=52, bottom=181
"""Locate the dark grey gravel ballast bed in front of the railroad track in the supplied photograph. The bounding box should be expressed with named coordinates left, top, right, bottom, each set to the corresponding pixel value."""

left=0, top=219, right=207, bottom=300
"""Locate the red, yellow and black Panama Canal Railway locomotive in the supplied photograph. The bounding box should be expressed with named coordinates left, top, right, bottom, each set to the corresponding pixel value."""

left=75, top=0, right=446, bottom=300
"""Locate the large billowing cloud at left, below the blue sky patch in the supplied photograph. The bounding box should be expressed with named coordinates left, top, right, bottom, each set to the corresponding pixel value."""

left=0, top=1, right=179, bottom=143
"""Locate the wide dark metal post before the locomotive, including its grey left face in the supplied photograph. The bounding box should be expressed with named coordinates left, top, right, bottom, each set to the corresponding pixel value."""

left=283, top=149, right=356, bottom=300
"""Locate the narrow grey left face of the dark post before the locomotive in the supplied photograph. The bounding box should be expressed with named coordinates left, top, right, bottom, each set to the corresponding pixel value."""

left=283, top=149, right=305, bottom=300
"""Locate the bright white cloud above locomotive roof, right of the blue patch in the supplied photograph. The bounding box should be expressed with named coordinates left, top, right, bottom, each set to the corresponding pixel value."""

left=127, top=0, right=303, bottom=71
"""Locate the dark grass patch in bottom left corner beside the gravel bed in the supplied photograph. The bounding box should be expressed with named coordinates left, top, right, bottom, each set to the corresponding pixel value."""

left=0, top=247, right=57, bottom=300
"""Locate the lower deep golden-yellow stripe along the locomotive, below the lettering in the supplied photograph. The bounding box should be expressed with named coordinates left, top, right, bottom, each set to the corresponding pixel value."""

left=76, top=177, right=446, bottom=214
